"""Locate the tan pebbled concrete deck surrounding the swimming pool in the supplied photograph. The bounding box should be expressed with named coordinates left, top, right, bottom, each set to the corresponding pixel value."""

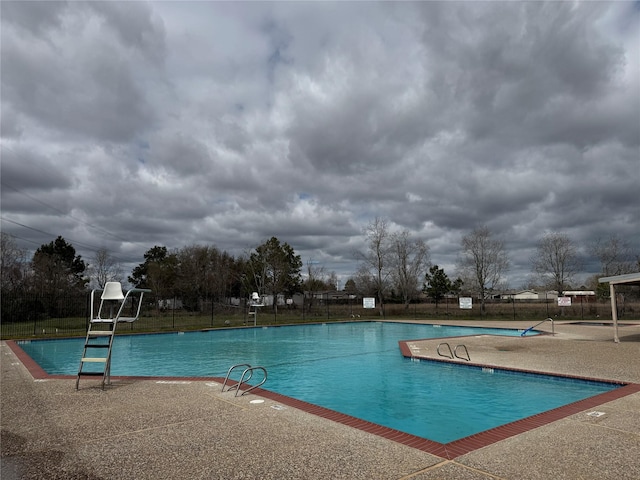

left=0, top=321, right=640, bottom=480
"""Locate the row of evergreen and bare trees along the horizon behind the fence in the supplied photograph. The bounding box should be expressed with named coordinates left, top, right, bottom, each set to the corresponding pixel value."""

left=0, top=223, right=640, bottom=314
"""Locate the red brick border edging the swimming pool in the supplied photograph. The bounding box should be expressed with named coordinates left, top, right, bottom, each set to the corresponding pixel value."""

left=5, top=340, right=640, bottom=460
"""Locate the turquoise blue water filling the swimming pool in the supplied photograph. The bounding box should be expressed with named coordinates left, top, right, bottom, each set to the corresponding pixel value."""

left=20, top=322, right=618, bottom=443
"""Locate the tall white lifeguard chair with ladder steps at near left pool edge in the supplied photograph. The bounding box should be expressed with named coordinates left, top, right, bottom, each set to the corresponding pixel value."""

left=76, top=282, right=151, bottom=390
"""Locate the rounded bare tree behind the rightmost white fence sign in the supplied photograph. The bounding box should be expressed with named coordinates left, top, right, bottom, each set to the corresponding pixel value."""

left=531, top=232, right=582, bottom=296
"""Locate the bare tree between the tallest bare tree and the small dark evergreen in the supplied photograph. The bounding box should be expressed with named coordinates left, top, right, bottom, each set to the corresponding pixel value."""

left=391, top=230, right=429, bottom=309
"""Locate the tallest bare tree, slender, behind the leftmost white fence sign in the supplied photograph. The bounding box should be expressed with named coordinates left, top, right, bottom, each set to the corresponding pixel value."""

left=357, top=217, right=391, bottom=316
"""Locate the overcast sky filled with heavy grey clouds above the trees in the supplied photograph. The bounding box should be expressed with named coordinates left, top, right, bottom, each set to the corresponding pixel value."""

left=1, top=1, right=640, bottom=288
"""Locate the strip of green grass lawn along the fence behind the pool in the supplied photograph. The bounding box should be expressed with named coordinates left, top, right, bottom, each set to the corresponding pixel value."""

left=0, top=302, right=640, bottom=339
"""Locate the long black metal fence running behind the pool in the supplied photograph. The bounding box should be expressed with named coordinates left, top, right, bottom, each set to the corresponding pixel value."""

left=0, top=293, right=640, bottom=339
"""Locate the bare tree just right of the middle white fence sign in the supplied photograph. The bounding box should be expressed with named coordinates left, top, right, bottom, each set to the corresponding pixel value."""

left=460, top=226, right=509, bottom=315
